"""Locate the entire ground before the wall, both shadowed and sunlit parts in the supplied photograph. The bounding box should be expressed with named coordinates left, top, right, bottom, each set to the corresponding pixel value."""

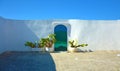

left=0, top=51, right=120, bottom=71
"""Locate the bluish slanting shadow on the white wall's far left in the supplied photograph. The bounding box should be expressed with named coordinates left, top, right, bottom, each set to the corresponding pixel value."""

left=0, top=20, right=39, bottom=53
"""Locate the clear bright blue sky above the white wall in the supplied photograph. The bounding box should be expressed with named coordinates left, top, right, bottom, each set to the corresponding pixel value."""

left=0, top=0, right=120, bottom=20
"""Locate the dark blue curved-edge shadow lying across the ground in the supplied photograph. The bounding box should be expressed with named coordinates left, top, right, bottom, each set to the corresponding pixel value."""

left=0, top=52, right=56, bottom=71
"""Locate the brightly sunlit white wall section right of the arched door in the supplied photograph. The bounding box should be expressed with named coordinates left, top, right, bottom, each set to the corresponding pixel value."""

left=69, top=20, right=120, bottom=50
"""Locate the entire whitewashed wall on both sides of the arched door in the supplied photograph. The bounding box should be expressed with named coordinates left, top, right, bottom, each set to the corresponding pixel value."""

left=0, top=18, right=120, bottom=53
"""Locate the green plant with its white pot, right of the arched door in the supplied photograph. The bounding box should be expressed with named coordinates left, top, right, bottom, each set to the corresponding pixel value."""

left=68, top=40, right=88, bottom=52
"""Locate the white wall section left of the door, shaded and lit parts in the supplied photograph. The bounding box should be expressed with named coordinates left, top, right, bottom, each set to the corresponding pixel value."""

left=0, top=18, right=52, bottom=53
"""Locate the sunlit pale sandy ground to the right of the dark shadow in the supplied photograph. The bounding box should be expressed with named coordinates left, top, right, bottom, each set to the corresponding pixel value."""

left=51, top=51, right=120, bottom=71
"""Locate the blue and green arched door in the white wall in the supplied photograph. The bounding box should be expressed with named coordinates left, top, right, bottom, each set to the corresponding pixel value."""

left=54, top=25, right=67, bottom=51
